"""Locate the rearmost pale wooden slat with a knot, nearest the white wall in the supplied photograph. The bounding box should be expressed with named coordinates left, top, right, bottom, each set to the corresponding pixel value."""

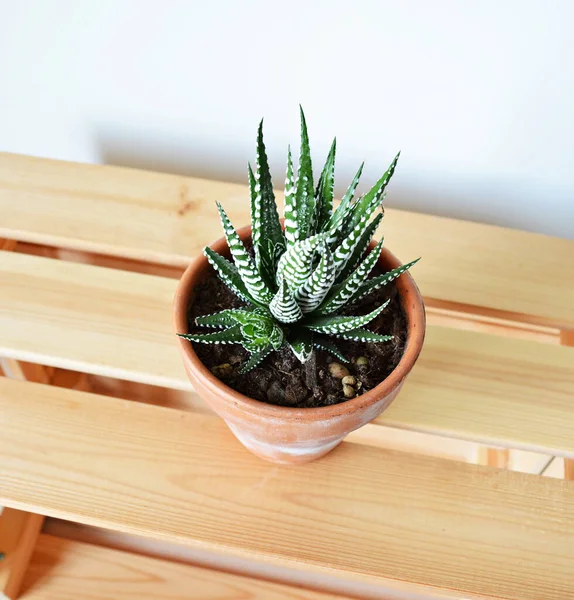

left=0, top=154, right=574, bottom=329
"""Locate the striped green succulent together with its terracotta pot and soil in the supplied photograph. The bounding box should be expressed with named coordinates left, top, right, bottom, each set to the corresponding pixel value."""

left=175, top=110, right=425, bottom=463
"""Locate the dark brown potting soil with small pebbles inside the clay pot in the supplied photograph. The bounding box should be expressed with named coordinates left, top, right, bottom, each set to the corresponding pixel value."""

left=188, top=271, right=407, bottom=408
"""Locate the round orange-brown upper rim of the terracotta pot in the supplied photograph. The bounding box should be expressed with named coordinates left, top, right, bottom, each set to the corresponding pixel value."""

left=173, top=226, right=426, bottom=421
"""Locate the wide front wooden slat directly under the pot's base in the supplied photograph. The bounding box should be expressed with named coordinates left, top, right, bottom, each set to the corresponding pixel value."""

left=0, top=379, right=574, bottom=600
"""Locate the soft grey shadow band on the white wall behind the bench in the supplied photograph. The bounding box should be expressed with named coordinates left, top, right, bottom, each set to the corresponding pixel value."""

left=94, top=127, right=574, bottom=239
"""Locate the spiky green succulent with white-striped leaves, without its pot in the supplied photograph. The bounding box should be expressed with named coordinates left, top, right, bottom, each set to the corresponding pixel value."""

left=183, top=109, right=417, bottom=372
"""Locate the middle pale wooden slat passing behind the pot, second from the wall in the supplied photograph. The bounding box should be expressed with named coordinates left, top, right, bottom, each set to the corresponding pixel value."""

left=0, top=248, right=574, bottom=456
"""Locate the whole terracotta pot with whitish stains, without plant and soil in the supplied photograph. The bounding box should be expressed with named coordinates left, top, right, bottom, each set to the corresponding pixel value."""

left=174, top=227, right=425, bottom=464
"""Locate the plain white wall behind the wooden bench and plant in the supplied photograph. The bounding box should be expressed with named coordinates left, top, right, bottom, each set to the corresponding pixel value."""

left=0, top=0, right=574, bottom=238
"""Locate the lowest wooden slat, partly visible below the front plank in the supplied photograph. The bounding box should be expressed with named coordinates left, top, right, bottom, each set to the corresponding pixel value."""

left=23, top=535, right=343, bottom=600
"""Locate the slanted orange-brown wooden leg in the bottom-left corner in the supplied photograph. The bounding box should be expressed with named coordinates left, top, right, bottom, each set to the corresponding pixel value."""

left=0, top=508, right=44, bottom=600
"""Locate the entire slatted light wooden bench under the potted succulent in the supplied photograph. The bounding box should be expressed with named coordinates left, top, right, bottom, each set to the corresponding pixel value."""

left=0, top=155, right=574, bottom=600
